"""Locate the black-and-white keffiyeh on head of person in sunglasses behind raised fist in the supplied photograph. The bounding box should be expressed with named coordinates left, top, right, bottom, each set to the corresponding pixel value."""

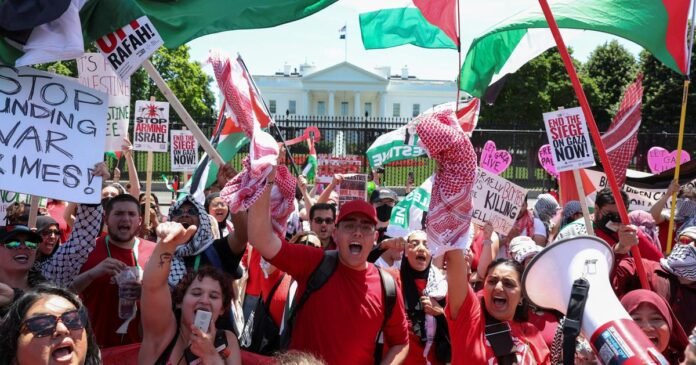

left=169, top=195, right=213, bottom=286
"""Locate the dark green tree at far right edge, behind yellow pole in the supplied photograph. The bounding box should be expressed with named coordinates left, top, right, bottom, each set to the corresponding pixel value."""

left=640, top=47, right=696, bottom=133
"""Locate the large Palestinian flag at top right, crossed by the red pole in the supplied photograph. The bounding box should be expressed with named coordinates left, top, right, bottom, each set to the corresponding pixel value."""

left=459, top=0, right=690, bottom=97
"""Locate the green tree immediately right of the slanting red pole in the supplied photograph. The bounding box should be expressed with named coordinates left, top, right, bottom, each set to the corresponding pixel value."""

left=582, top=40, right=637, bottom=131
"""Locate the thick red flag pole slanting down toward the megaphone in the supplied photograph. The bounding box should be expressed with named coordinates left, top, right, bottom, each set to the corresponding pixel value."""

left=539, top=0, right=650, bottom=289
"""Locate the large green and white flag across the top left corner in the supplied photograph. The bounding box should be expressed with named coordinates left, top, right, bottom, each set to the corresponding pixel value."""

left=0, top=0, right=337, bottom=65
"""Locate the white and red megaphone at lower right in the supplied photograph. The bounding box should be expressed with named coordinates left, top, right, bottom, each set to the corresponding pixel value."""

left=522, top=236, right=668, bottom=365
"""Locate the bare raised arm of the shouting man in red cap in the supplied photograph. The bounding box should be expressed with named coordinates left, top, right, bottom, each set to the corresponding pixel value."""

left=247, top=167, right=281, bottom=260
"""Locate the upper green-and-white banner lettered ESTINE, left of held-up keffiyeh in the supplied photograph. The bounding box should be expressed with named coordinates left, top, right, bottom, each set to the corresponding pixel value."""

left=365, top=126, right=425, bottom=169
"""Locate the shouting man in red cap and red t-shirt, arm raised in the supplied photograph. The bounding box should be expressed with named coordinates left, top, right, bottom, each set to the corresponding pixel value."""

left=248, top=173, right=408, bottom=365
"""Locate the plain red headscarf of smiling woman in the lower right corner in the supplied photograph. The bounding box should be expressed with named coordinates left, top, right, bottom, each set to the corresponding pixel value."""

left=621, top=289, right=689, bottom=354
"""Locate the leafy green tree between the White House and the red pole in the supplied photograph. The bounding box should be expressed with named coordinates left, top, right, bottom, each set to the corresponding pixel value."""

left=479, top=48, right=598, bottom=129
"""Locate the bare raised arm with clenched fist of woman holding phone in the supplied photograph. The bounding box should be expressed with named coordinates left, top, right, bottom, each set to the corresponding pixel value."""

left=140, top=222, right=197, bottom=356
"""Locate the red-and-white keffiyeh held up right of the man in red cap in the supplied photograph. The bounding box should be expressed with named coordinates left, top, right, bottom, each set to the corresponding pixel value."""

left=413, top=111, right=476, bottom=257
